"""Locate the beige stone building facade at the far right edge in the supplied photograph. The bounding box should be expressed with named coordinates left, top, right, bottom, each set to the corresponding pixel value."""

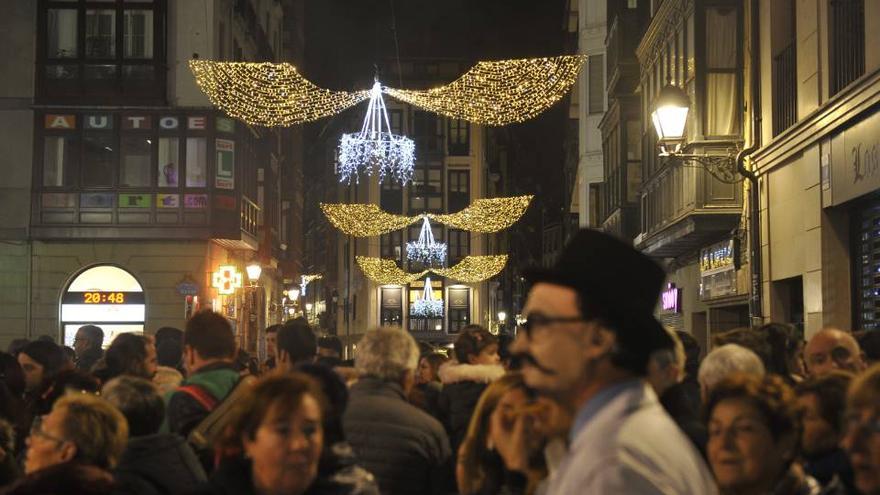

left=753, top=0, right=880, bottom=337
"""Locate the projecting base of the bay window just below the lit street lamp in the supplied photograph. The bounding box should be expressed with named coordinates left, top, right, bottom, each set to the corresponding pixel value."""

left=635, top=149, right=742, bottom=258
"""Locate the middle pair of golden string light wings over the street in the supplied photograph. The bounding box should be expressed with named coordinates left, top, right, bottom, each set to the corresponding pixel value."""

left=321, top=196, right=534, bottom=237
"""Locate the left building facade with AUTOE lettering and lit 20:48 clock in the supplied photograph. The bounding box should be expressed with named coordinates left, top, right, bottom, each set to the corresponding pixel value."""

left=0, top=0, right=301, bottom=352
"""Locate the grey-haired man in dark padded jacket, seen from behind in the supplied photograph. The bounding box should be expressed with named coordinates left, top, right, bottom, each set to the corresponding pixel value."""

left=342, top=327, right=454, bottom=494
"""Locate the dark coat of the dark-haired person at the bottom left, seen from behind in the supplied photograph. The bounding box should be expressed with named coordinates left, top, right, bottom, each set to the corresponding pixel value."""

left=113, top=433, right=207, bottom=495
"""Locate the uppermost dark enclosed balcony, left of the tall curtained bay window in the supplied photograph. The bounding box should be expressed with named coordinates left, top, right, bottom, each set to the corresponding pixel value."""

left=605, top=10, right=641, bottom=97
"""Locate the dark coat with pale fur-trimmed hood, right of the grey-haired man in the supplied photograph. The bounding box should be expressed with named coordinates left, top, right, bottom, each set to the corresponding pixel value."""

left=438, top=363, right=504, bottom=454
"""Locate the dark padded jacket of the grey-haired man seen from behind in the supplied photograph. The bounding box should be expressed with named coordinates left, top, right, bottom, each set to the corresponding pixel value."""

left=342, top=377, right=454, bottom=495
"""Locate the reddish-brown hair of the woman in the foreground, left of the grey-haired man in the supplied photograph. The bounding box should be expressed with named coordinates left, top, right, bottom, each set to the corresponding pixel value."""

left=221, top=372, right=328, bottom=455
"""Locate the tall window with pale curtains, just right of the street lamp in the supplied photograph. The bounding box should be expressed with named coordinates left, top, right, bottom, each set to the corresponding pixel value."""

left=705, top=7, right=740, bottom=136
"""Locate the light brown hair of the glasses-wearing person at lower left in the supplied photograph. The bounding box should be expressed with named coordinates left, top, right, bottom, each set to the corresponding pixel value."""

left=52, top=392, right=128, bottom=469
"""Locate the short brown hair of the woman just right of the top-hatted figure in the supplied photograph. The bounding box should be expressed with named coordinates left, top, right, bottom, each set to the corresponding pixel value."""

left=705, top=373, right=801, bottom=441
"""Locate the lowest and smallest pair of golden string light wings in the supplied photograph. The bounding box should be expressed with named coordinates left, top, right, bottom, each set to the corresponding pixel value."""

left=355, top=254, right=507, bottom=285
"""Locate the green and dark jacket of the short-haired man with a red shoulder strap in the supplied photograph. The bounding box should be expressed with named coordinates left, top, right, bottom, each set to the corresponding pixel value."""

left=165, top=363, right=240, bottom=438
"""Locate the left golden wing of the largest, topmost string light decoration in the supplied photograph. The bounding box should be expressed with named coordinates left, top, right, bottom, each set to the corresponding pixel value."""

left=189, top=60, right=370, bottom=127
